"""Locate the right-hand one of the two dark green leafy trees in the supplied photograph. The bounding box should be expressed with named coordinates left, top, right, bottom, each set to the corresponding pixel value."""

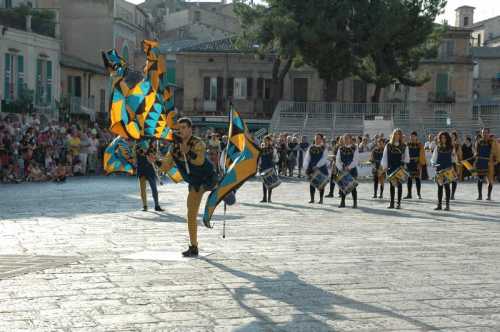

left=352, top=0, right=446, bottom=102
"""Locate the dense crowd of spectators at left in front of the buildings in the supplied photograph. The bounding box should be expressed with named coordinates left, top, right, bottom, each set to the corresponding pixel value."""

left=0, top=115, right=112, bottom=183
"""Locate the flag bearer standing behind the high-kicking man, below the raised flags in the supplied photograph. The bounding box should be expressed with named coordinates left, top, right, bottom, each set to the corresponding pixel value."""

left=136, top=140, right=163, bottom=211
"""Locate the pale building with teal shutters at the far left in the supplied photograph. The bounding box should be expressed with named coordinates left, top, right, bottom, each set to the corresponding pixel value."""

left=0, top=3, right=61, bottom=117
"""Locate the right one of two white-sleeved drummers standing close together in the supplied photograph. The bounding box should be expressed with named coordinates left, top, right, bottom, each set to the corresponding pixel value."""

left=335, top=134, right=359, bottom=209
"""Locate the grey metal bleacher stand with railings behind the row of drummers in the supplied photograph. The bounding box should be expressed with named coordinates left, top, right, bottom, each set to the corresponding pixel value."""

left=270, top=101, right=500, bottom=137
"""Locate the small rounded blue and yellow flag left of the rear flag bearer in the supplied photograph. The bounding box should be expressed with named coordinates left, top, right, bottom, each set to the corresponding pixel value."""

left=103, top=136, right=135, bottom=175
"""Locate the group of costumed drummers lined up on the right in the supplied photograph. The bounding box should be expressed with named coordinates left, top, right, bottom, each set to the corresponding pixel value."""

left=260, top=128, right=500, bottom=211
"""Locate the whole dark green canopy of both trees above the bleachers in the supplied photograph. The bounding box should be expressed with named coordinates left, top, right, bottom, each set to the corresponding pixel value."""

left=235, top=0, right=446, bottom=101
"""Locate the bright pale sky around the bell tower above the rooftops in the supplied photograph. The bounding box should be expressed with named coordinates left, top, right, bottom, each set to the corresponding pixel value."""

left=128, top=0, right=500, bottom=25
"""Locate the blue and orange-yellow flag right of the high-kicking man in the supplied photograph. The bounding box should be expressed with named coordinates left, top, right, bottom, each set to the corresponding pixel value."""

left=203, top=108, right=260, bottom=228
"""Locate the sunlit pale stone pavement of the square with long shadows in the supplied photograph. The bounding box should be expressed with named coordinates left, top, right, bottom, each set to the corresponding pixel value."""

left=0, top=177, right=500, bottom=331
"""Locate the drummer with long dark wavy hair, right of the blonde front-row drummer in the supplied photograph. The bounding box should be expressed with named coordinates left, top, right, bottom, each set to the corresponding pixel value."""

left=431, top=132, right=457, bottom=211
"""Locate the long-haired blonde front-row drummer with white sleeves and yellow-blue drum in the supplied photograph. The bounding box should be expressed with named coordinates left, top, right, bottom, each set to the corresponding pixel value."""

left=382, top=129, right=410, bottom=209
